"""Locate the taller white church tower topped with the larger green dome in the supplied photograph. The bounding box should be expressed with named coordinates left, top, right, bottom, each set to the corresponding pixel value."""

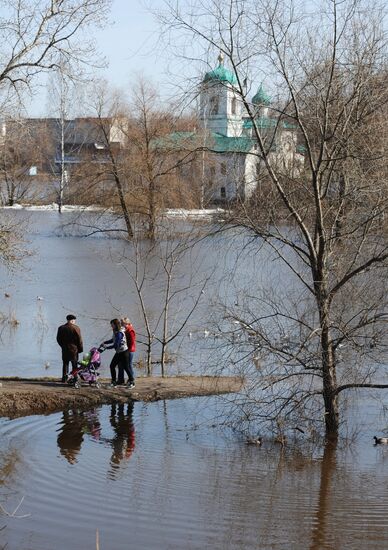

left=199, top=53, right=242, bottom=137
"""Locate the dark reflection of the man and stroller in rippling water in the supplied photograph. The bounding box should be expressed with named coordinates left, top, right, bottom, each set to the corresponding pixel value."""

left=57, top=409, right=101, bottom=464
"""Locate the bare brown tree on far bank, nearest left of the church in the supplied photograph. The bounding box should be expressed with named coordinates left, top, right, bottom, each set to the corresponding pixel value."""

left=128, top=79, right=205, bottom=239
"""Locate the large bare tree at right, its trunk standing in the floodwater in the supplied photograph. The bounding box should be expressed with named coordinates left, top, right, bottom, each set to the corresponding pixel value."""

left=160, top=0, right=388, bottom=437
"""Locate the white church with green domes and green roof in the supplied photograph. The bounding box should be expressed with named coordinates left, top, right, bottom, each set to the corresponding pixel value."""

left=199, top=55, right=304, bottom=202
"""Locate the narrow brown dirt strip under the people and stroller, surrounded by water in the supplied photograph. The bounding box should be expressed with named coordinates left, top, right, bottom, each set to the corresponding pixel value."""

left=0, top=376, right=242, bottom=417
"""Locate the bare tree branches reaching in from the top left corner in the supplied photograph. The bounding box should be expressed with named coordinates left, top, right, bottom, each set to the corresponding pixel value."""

left=0, top=0, right=110, bottom=266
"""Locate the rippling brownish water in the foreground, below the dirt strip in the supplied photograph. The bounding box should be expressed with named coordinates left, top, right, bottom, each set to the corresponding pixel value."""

left=0, top=398, right=388, bottom=550
